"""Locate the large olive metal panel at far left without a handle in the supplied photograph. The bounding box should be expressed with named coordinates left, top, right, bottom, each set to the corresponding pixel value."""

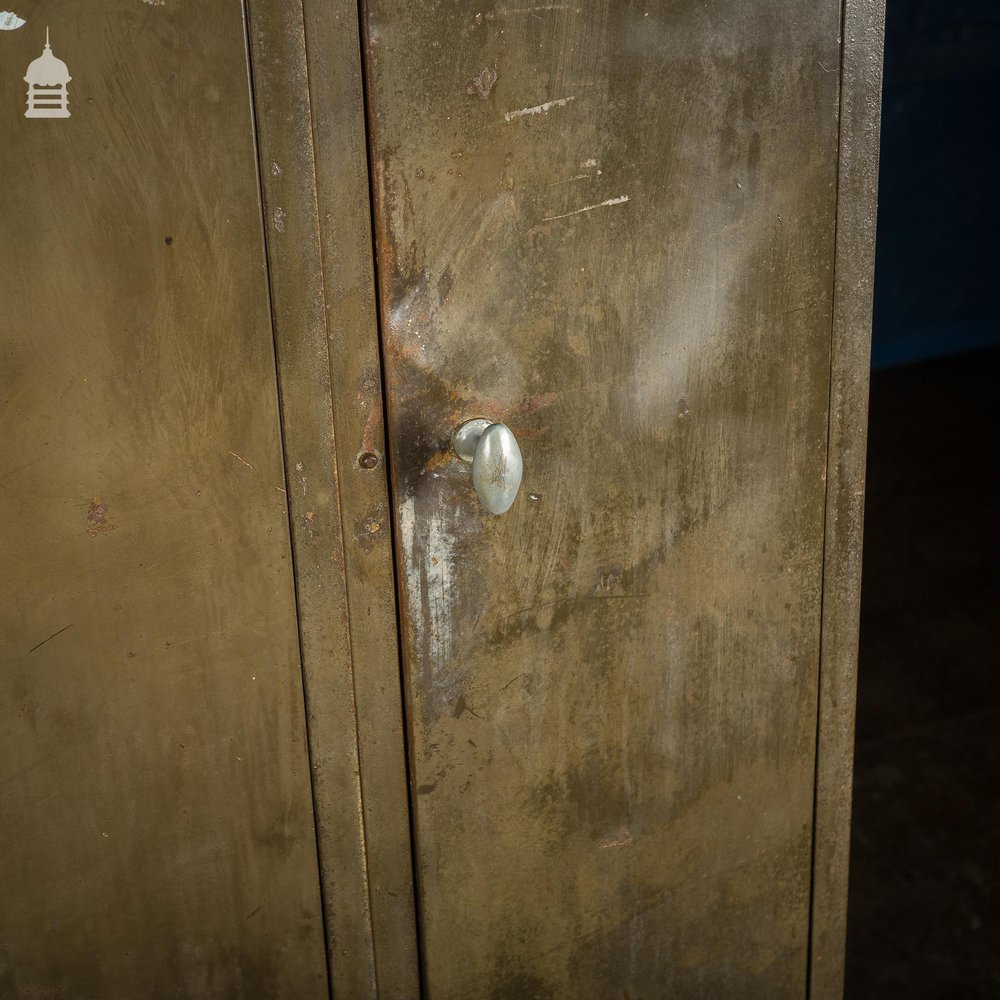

left=0, top=0, right=327, bottom=1000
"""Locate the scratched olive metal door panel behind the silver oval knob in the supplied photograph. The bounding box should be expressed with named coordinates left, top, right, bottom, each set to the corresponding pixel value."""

left=365, top=0, right=840, bottom=1000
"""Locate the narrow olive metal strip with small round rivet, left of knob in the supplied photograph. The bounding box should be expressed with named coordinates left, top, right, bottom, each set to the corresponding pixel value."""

left=292, top=0, right=419, bottom=988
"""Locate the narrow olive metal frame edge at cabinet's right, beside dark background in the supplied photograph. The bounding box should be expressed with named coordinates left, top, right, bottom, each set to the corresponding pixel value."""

left=809, top=0, right=885, bottom=1000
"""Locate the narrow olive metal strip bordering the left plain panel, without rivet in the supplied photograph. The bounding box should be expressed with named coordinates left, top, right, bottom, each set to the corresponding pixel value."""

left=248, top=0, right=384, bottom=998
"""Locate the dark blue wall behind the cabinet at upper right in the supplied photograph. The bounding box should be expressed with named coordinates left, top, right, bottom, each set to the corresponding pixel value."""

left=872, top=0, right=1000, bottom=367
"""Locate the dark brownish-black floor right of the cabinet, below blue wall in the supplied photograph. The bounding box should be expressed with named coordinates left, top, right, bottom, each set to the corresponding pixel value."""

left=846, top=352, right=1000, bottom=1000
